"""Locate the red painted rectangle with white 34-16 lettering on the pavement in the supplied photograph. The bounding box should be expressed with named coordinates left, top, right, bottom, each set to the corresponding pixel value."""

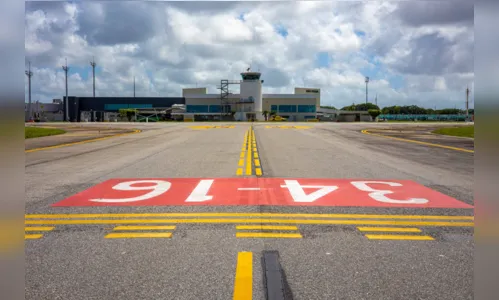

left=52, top=178, right=473, bottom=208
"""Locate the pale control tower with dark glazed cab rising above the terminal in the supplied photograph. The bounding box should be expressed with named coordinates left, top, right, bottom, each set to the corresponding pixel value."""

left=241, top=69, right=265, bottom=121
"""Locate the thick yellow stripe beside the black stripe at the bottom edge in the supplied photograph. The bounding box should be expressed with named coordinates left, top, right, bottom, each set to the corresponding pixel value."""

left=232, top=252, right=253, bottom=300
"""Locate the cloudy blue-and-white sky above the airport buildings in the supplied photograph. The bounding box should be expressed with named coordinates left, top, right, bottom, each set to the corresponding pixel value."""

left=25, top=0, right=474, bottom=108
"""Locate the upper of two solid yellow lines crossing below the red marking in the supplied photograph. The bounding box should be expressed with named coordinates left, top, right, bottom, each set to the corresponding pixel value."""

left=25, top=213, right=475, bottom=221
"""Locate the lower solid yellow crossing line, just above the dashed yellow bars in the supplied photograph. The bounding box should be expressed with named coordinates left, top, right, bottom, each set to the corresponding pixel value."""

left=25, top=218, right=474, bottom=227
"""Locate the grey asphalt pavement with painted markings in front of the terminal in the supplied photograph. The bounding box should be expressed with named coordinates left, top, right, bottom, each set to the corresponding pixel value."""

left=25, top=123, right=474, bottom=300
